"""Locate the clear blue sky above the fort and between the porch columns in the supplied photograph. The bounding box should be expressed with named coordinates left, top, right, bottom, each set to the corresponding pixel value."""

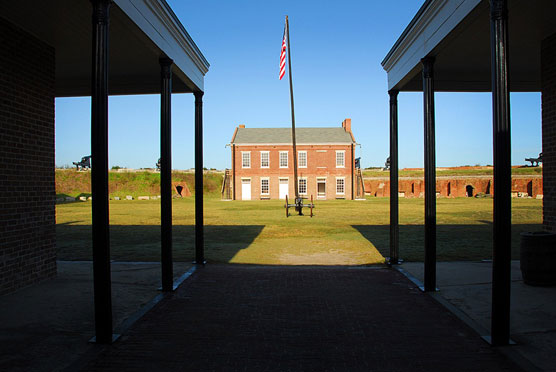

left=56, top=0, right=541, bottom=169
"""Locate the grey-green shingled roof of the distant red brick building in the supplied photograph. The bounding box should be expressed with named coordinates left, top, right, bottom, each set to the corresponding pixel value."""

left=232, top=128, right=355, bottom=145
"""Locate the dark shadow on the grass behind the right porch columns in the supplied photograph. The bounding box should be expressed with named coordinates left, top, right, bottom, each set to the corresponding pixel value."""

left=352, top=221, right=542, bottom=261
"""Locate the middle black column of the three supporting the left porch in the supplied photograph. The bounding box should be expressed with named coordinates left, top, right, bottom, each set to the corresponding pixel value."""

left=160, top=58, right=174, bottom=292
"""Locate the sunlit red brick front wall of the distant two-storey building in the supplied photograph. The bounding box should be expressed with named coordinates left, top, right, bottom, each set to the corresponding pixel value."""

left=232, top=145, right=355, bottom=200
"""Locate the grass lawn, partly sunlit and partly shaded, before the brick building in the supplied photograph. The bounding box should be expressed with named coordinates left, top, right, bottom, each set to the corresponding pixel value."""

left=56, top=197, right=542, bottom=265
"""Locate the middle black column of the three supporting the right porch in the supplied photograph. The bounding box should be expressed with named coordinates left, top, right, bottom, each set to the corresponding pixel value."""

left=421, top=58, right=436, bottom=292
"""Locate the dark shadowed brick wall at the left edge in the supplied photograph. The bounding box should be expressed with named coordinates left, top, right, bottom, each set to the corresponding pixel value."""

left=0, top=17, right=56, bottom=295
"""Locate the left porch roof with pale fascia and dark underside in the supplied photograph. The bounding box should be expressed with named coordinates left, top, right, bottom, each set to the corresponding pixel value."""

left=0, top=0, right=209, bottom=97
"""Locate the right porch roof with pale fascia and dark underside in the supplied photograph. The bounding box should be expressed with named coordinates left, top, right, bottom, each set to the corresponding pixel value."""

left=382, top=0, right=556, bottom=92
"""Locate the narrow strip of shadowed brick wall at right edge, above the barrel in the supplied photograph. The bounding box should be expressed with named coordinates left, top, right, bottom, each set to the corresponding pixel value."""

left=541, top=34, right=556, bottom=231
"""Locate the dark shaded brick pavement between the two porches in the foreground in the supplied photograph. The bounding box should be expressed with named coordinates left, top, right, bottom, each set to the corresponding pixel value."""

left=79, top=265, right=518, bottom=371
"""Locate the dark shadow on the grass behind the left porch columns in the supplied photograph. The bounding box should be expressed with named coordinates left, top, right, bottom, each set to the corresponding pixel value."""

left=56, top=224, right=264, bottom=262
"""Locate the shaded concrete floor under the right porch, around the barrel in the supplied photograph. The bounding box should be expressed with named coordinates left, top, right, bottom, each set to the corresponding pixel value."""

left=400, top=261, right=556, bottom=371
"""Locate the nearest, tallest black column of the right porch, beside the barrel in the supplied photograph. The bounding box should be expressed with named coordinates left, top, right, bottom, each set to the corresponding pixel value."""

left=490, top=0, right=512, bottom=346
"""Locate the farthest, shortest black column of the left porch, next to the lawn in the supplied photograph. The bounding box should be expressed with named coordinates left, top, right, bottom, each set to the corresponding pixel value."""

left=194, top=92, right=205, bottom=264
